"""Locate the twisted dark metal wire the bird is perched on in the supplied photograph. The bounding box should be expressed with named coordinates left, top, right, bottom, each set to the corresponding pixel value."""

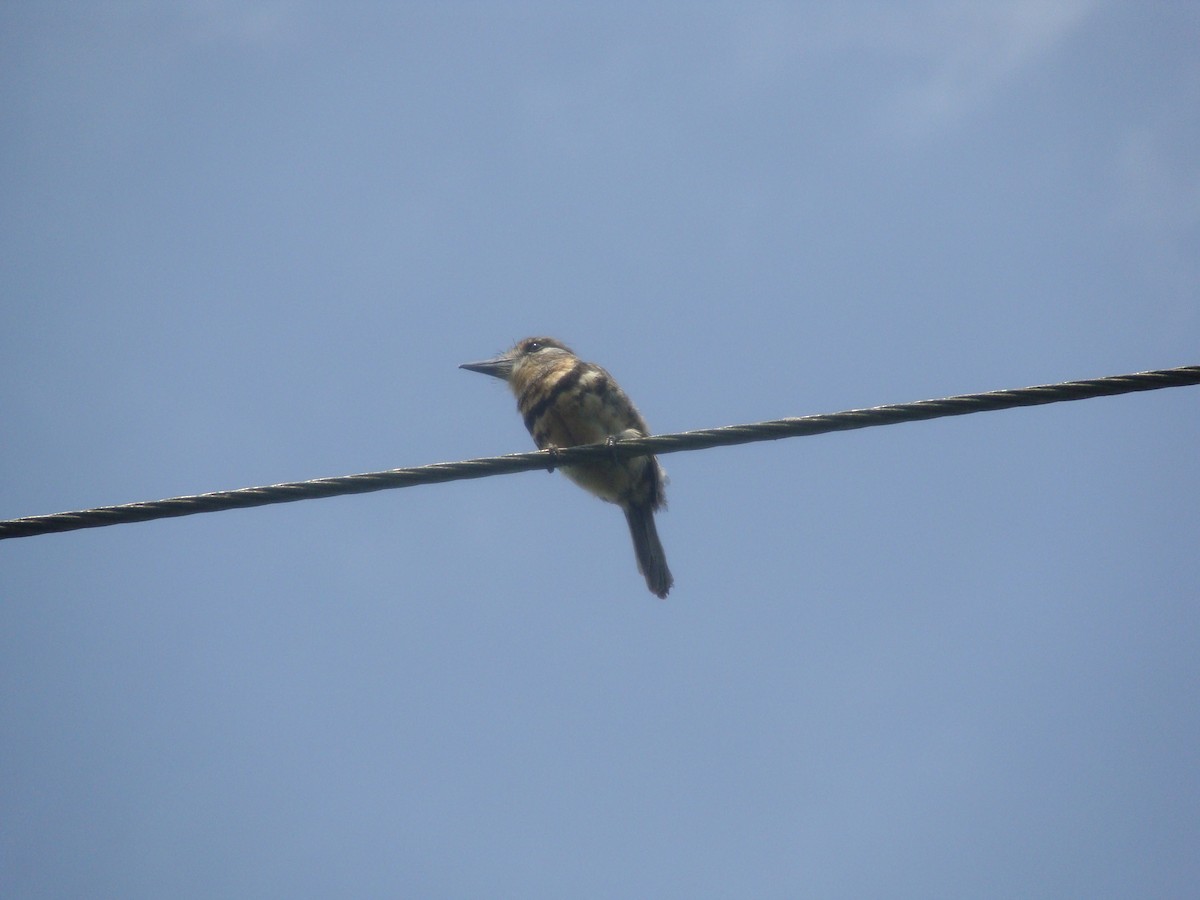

left=0, top=366, right=1200, bottom=540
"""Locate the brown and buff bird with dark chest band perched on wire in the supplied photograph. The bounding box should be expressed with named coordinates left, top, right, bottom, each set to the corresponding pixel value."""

left=460, top=337, right=674, bottom=599
